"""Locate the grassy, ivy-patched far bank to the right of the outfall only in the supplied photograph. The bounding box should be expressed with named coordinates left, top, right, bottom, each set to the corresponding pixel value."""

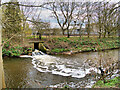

left=44, top=37, right=120, bottom=54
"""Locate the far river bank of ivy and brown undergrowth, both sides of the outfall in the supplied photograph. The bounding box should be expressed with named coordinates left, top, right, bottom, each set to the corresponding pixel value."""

left=2, top=37, right=120, bottom=57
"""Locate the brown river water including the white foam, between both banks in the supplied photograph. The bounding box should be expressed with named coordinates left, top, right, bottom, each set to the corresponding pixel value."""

left=4, top=49, right=118, bottom=88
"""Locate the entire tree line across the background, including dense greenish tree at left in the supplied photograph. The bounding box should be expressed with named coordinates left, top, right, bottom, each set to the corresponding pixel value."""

left=2, top=0, right=119, bottom=41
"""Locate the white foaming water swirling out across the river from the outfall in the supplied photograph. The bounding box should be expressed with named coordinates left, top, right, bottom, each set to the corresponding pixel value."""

left=32, top=54, right=100, bottom=78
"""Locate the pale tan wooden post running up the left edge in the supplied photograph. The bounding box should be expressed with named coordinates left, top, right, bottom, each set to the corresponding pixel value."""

left=0, top=0, right=5, bottom=90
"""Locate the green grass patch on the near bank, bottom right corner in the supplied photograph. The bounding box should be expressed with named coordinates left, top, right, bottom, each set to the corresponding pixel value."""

left=93, top=77, right=120, bottom=88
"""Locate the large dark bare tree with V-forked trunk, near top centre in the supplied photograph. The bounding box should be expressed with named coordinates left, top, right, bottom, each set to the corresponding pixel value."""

left=50, top=2, right=76, bottom=38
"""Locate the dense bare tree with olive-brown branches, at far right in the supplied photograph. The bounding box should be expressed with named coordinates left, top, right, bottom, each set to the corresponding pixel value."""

left=94, top=2, right=118, bottom=38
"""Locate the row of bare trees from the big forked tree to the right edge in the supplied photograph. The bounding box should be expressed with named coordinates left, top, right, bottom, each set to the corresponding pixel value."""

left=47, top=1, right=119, bottom=38
